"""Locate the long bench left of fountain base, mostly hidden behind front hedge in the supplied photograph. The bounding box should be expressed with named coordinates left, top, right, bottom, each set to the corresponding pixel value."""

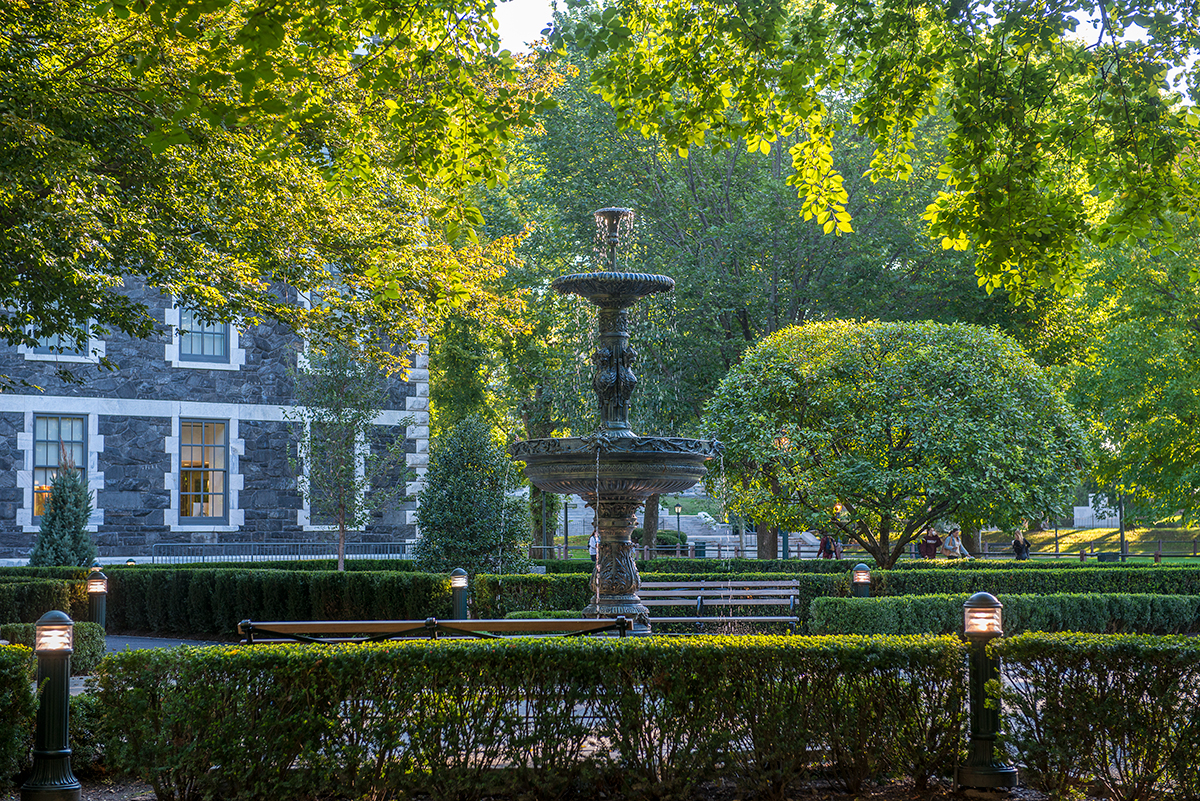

left=238, top=618, right=632, bottom=645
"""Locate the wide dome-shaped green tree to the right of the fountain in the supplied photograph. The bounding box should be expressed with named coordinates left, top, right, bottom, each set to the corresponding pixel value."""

left=706, top=321, right=1087, bottom=567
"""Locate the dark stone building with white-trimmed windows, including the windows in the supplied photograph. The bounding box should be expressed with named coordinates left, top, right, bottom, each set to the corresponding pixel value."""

left=0, top=286, right=428, bottom=558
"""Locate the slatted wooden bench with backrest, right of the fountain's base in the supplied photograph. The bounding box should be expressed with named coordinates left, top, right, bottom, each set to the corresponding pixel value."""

left=637, top=579, right=800, bottom=633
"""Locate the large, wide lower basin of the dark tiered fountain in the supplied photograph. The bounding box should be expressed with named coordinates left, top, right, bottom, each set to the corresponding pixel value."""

left=511, top=436, right=720, bottom=498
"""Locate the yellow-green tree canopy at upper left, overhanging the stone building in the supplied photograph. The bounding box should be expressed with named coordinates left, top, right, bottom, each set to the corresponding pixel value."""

left=0, top=0, right=535, bottom=381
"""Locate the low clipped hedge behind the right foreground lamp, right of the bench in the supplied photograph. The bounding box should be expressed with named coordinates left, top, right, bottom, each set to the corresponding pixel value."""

left=809, top=592, right=1200, bottom=636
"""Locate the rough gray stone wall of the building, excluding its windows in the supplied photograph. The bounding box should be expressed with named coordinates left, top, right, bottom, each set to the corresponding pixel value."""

left=0, top=281, right=425, bottom=558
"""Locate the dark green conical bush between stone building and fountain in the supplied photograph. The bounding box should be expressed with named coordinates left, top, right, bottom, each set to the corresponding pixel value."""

left=416, top=415, right=530, bottom=574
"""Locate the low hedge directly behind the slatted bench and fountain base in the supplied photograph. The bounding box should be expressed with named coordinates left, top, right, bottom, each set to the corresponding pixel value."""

left=472, top=572, right=850, bottom=620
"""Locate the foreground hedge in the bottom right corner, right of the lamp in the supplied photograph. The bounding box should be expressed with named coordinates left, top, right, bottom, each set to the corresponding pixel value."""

left=992, top=633, right=1200, bottom=801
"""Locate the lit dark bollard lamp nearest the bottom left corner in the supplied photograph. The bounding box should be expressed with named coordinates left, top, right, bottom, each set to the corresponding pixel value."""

left=20, top=610, right=80, bottom=801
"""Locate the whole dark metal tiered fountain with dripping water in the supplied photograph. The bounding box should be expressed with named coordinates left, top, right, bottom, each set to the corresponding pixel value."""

left=511, top=209, right=720, bottom=633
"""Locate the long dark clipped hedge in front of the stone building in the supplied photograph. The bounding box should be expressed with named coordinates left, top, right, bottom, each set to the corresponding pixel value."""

left=106, top=567, right=451, bottom=637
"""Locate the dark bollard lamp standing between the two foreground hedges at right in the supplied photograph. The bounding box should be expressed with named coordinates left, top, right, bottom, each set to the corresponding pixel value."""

left=955, top=592, right=1016, bottom=789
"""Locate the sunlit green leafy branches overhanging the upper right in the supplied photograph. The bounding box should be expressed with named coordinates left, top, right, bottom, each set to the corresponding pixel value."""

left=572, top=0, right=1200, bottom=299
